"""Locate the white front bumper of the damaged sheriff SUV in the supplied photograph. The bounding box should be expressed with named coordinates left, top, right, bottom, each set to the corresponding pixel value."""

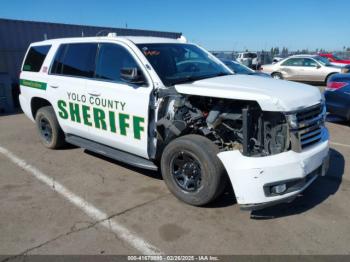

left=218, top=128, right=329, bottom=210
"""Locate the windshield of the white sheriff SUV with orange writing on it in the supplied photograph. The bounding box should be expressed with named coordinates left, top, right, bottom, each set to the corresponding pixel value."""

left=137, top=44, right=232, bottom=86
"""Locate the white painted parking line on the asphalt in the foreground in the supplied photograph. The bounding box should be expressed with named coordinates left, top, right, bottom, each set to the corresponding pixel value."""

left=0, top=146, right=161, bottom=255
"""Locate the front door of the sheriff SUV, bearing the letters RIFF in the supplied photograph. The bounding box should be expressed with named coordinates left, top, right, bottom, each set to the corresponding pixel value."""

left=87, top=43, right=152, bottom=158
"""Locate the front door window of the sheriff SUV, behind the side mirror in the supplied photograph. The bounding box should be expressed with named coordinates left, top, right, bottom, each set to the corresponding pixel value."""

left=96, top=44, right=138, bottom=82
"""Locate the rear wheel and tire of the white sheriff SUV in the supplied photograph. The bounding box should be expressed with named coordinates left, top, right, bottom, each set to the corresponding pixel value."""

left=35, top=106, right=66, bottom=149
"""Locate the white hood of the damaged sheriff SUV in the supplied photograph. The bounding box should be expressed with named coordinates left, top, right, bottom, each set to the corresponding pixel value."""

left=175, top=75, right=322, bottom=112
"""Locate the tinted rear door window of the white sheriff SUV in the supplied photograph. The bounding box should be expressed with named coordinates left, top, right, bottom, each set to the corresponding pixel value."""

left=51, top=43, right=97, bottom=77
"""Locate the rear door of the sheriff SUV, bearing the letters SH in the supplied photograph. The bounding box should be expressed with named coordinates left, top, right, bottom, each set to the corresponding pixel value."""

left=48, top=43, right=97, bottom=138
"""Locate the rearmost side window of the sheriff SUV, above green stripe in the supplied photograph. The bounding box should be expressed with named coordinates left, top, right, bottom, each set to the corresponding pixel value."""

left=23, top=45, right=51, bottom=72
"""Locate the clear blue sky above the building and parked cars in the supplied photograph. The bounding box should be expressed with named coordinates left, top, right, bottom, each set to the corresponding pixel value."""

left=0, top=0, right=350, bottom=50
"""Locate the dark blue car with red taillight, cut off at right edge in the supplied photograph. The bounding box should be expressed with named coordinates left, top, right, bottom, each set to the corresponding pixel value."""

left=325, top=73, right=350, bottom=121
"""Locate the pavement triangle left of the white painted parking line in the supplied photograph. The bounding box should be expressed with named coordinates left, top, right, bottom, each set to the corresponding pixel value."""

left=0, top=150, right=133, bottom=255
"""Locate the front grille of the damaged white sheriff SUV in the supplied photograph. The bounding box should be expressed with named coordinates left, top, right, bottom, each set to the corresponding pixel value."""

left=290, top=103, right=326, bottom=152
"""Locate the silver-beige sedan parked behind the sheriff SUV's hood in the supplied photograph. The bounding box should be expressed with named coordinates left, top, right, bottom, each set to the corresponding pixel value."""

left=261, top=55, right=341, bottom=83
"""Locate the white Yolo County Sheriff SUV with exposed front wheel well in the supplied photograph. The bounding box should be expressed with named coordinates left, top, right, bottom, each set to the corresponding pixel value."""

left=20, top=36, right=328, bottom=209
